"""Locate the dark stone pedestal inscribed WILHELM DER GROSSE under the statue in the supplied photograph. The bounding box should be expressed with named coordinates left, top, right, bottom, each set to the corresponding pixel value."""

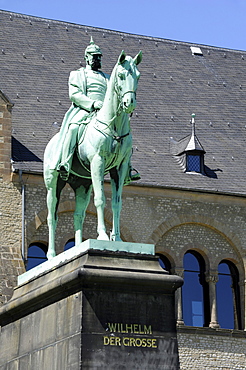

left=0, top=241, right=182, bottom=370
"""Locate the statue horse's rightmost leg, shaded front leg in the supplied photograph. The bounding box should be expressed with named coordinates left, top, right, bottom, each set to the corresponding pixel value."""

left=110, top=162, right=129, bottom=241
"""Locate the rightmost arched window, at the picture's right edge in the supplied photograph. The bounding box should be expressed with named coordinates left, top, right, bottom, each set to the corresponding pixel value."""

left=216, top=260, right=242, bottom=329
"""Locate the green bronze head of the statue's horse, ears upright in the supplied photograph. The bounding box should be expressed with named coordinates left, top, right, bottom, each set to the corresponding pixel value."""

left=115, top=50, right=142, bottom=113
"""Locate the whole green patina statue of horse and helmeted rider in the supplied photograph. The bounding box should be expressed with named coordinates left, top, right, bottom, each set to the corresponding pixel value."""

left=44, top=39, right=142, bottom=258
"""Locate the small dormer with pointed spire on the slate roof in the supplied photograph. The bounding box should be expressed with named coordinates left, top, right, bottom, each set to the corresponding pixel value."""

left=170, top=114, right=205, bottom=175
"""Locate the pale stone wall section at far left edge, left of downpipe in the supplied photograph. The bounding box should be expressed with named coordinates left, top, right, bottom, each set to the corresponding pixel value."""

left=0, top=90, right=25, bottom=305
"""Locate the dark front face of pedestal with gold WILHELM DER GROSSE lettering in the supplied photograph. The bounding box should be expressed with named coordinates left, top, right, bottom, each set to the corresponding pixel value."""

left=82, top=291, right=178, bottom=370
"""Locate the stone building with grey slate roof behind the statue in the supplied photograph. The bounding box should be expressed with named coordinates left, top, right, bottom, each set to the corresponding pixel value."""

left=0, top=12, right=246, bottom=370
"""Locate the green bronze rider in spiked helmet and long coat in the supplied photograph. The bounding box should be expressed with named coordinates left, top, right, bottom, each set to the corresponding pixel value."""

left=57, top=38, right=140, bottom=184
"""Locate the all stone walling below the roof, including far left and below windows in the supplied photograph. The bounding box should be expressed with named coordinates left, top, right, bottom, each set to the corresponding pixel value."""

left=0, top=174, right=246, bottom=369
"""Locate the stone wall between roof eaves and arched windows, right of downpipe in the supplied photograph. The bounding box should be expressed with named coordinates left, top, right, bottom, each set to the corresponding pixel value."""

left=7, top=175, right=246, bottom=304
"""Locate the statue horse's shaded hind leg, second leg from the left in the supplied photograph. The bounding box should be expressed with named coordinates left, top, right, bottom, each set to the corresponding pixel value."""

left=73, top=180, right=92, bottom=247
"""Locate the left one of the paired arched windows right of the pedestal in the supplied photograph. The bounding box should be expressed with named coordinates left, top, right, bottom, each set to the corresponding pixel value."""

left=182, top=251, right=210, bottom=327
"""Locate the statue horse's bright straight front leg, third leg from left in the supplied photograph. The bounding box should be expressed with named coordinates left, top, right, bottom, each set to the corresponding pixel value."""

left=91, top=155, right=109, bottom=240
